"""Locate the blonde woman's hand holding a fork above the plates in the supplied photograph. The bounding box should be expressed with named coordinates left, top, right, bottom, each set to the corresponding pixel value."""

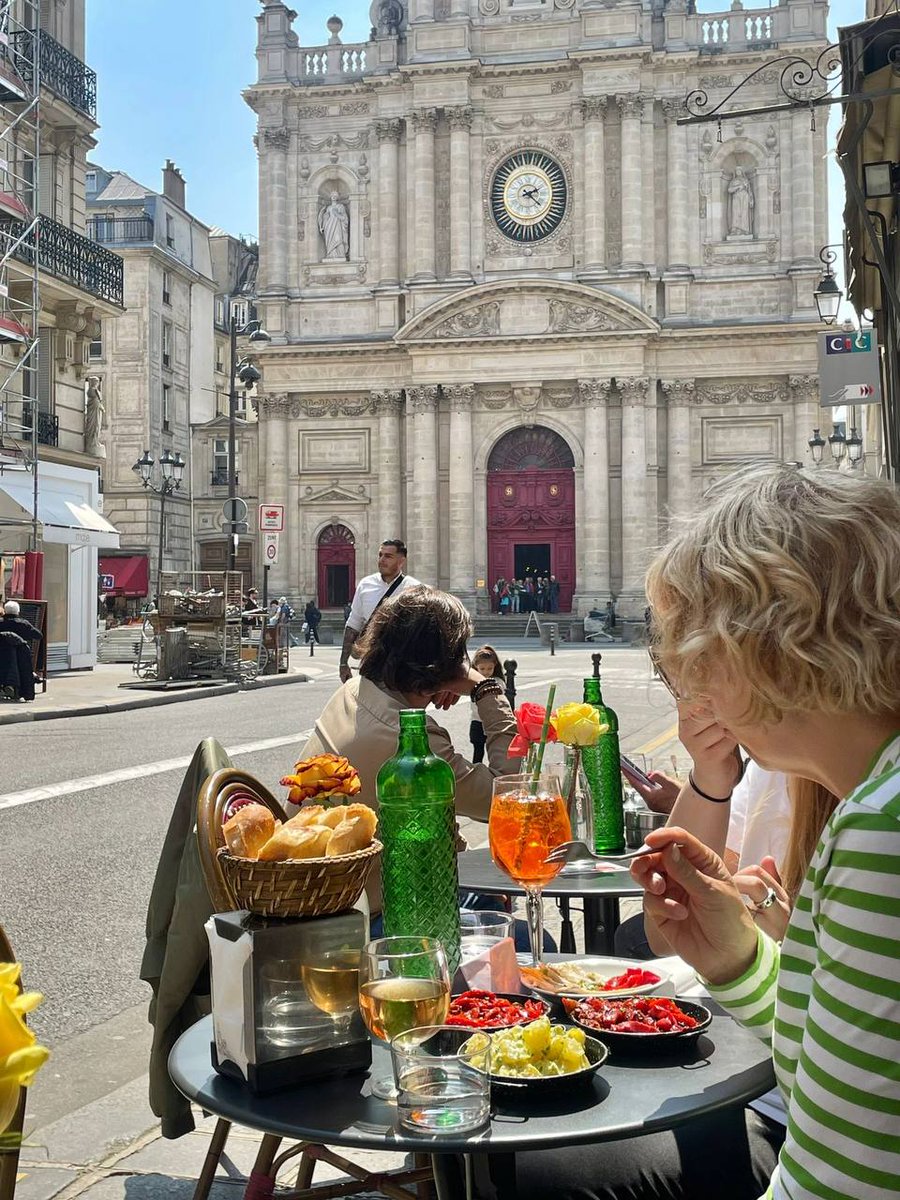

left=631, top=826, right=757, bottom=984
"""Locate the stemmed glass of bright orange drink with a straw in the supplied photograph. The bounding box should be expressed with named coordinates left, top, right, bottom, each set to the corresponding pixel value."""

left=487, top=772, right=572, bottom=966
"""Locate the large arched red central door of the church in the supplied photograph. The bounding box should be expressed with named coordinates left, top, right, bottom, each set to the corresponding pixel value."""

left=487, top=425, right=575, bottom=612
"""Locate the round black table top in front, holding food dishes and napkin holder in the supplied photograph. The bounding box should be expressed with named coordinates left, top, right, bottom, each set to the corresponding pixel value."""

left=169, top=1015, right=774, bottom=1153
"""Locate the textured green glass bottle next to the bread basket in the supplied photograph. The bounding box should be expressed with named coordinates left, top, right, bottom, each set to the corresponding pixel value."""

left=376, top=708, right=460, bottom=976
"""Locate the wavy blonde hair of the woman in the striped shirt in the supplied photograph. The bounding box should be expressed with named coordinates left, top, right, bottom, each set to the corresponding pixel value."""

left=647, top=466, right=900, bottom=721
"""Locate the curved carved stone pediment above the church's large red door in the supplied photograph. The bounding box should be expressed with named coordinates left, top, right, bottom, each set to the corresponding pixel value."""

left=396, top=280, right=659, bottom=343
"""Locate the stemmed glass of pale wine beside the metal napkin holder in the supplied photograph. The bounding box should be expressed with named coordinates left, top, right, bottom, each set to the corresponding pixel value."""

left=359, top=937, right=450, bottom=1100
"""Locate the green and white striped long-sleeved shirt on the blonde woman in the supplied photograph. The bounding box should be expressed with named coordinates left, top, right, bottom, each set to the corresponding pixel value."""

left=709, top=736, right=900, bottom=1200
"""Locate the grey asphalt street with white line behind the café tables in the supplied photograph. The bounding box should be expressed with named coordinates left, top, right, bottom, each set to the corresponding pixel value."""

left=0, top=642, right=673, bottom=1195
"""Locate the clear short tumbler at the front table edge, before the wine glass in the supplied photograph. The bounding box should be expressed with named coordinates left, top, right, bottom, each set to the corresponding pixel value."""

left=391, top=1025, right=491, bottom=1134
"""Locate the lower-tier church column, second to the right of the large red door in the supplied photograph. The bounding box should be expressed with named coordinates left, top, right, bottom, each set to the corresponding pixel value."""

left=616, top=378, right=650, bottom=617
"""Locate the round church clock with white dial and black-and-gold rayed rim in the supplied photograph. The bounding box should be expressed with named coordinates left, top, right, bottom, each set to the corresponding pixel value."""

left=491, top=150, right=566, bottom=241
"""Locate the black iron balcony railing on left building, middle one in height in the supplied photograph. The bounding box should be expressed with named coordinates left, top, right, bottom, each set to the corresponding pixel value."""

left=0, top=216, right=125, bottom=307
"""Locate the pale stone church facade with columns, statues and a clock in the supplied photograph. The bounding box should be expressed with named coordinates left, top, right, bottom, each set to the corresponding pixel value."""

left=246, top=0, right=827, bottom=614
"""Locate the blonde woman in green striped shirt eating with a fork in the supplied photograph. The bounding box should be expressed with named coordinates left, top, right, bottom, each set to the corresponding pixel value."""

left=631, top=467, right=900, bottom=1200
